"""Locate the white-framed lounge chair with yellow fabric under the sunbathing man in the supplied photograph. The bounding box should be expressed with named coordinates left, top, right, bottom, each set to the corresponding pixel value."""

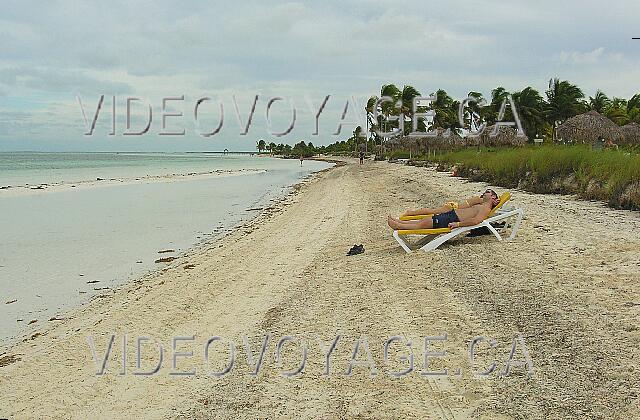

left=393, top=192, right=524, bottom=254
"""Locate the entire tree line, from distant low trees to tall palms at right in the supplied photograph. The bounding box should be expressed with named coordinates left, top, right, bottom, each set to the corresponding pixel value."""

left=256, top=78, right=640, bottom=156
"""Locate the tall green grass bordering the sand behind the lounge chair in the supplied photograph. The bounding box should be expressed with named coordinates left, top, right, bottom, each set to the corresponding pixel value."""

left=423, top=145, right=640, bottom=209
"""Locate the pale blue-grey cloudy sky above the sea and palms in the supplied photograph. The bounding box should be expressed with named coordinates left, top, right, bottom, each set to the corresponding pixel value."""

left=0, top=0, right=640, bottom=151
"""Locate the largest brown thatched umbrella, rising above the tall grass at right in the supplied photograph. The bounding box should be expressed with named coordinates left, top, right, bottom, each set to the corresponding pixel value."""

left=556, top=111, right=624, bottom=143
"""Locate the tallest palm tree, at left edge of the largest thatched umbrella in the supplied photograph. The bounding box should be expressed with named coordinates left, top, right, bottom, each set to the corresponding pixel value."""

left=545, top=78, right=587, bottom=140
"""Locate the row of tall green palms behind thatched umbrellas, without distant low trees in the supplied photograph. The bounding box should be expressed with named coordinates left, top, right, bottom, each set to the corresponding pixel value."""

left=365, top=78, right=640, bottom=144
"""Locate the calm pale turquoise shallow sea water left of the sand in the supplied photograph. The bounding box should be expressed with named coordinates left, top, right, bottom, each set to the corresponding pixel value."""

left=0, top=153, right=329, bottom=344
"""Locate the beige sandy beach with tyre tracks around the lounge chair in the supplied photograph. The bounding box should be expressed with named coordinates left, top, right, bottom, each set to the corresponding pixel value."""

left=0, top=159, right=640, bottom=419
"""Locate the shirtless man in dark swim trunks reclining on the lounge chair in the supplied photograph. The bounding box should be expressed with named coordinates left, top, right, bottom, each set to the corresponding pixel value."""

left=387, top=190, right=500, bottom=230
